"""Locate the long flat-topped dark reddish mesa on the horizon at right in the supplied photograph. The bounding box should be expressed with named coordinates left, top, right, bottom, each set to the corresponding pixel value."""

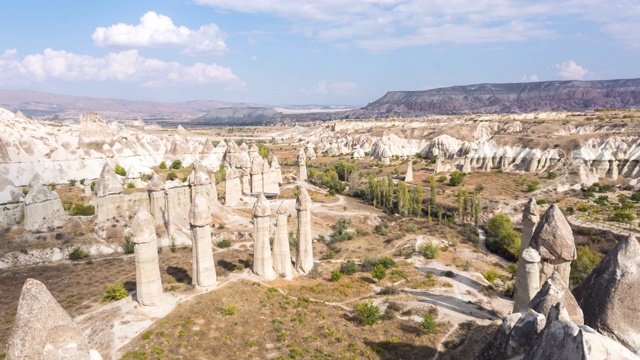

left=351, top=79, right=640, bottom=118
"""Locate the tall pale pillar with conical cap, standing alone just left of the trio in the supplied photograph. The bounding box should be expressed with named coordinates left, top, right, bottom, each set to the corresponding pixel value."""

left=189, top=194, right=216, bottom=289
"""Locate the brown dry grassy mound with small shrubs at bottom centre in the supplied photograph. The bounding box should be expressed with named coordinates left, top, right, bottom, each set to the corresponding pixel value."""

left=123, top=281, right=449, bottom=359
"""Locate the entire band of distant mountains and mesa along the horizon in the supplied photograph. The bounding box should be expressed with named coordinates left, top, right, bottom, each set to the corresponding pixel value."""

left=0, top=79, right=640, bottom=125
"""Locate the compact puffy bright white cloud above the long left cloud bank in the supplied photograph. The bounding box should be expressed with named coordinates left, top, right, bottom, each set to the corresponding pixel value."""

left=91, top=11, right=227, bottom=55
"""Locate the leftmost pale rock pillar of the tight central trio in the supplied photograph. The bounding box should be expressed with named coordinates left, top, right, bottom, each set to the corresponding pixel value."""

left=253, top=193, right=276, bottom=280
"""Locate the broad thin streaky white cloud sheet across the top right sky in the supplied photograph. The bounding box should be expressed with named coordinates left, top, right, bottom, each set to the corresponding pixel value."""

left=195, top=0, right=640, bottom=51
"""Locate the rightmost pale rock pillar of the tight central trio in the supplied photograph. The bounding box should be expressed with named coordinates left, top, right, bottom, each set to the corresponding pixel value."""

left=296, top=188, right=313, bottom=274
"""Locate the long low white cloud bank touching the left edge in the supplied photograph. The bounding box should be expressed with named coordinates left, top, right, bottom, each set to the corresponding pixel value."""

left=0, top=49, right=244, bottom=87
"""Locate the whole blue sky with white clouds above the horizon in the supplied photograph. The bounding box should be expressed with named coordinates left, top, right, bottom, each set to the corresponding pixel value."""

left=0, top=0, right=640, bottom=106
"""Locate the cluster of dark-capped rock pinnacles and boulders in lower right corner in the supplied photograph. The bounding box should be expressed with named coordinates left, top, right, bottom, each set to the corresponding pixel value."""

left=477, top=199, right=640, bottom=360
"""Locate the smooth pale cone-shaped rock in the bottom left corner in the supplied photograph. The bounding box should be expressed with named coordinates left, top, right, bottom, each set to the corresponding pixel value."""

left=6, top=279, right=102, bottom=360
